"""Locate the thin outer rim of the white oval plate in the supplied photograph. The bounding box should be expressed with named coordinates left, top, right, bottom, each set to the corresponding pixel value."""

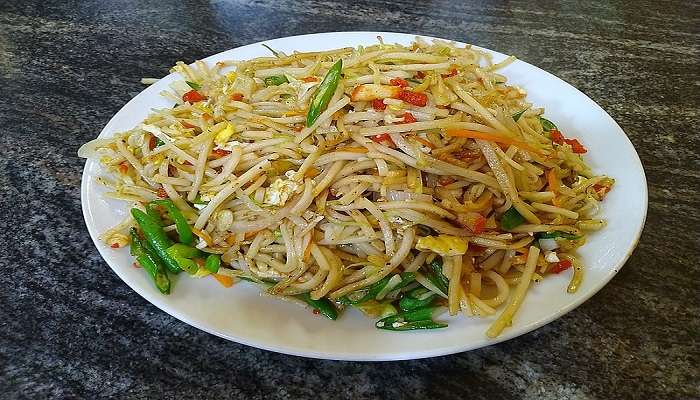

left=80, top=31, right=649, bottom=361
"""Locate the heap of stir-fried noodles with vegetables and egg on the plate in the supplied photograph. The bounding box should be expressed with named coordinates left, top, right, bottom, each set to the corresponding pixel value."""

left=81, top=40, right=613, bottom=337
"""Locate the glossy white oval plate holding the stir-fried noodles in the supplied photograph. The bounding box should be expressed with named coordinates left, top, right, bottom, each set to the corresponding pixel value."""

left=81, top=32, right=647, bottom=361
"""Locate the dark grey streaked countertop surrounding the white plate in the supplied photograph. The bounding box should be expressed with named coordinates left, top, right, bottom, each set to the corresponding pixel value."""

left=0, top=0, right=700, bottom=399
